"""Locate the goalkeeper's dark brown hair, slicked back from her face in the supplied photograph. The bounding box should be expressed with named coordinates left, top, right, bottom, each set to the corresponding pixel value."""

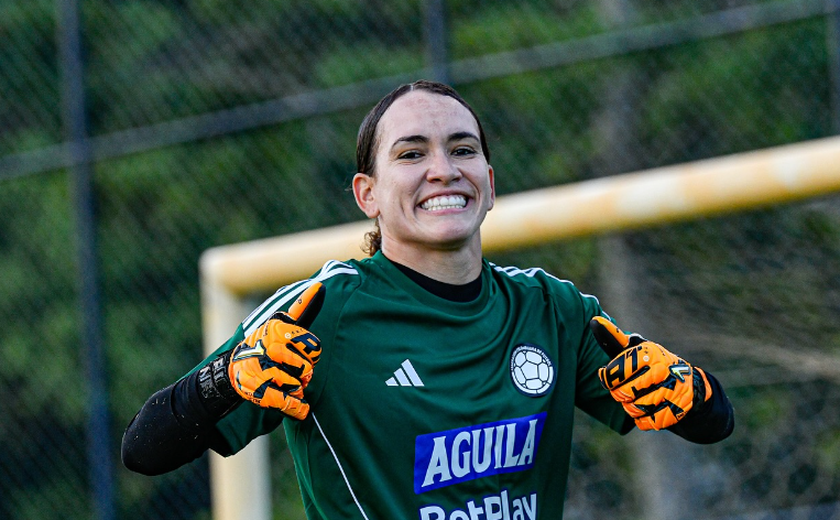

left=356, top=79, right=490, bottom=256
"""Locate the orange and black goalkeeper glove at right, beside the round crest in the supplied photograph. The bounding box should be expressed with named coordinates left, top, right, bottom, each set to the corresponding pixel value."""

left=589, top=316, right=712, bottom=430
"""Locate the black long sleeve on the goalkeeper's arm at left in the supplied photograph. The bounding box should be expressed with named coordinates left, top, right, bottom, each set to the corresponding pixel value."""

left=122, top=360, right=244, bottom=475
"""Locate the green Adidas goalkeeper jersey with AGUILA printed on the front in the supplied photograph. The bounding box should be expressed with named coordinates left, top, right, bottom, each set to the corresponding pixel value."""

left=205, top=253, right=626, bottom=520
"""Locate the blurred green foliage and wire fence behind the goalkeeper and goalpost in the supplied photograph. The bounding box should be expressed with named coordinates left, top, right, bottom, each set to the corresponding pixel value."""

left=0, top=0, right=840, bottom=520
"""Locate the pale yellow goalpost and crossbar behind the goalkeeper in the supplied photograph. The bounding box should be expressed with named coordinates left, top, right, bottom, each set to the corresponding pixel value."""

left=199, top=137, right=840, bottom=520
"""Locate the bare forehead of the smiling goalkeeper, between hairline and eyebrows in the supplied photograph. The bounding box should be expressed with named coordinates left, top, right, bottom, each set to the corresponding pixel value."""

left=379, top=90, right=478, bottom=144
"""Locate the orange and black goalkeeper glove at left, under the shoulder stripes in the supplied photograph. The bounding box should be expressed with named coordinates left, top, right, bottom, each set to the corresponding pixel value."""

left=228, top=282, right=324, bottom=419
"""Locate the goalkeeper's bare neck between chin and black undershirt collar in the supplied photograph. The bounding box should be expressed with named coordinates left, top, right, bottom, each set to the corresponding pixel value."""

left=382, top=237, right=482, bottom=285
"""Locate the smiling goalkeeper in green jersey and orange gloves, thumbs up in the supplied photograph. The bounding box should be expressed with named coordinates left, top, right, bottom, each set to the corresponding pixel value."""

left=122, top=81, right=734, bottom=520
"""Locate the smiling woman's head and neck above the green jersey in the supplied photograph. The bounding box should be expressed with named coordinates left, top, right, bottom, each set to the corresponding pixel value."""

left=353, top=83, right=495, bottom=284
